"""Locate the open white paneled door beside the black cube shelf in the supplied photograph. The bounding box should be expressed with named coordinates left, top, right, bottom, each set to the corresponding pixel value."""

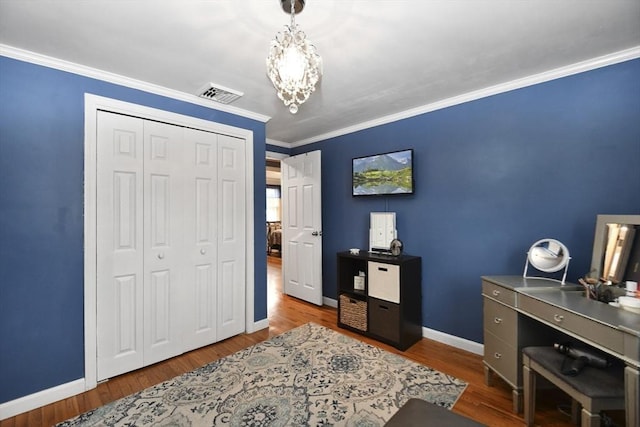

left=281, top=151, right=322, bottom=305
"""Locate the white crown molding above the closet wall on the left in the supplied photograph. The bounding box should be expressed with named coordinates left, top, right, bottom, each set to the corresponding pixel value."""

left=0, top=44, right=271, bottom=123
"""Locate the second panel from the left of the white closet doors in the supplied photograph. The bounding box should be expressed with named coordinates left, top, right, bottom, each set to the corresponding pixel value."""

left=143, top=121, right=187, bottom=366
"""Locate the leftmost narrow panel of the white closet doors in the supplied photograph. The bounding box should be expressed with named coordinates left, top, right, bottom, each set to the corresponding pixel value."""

left=96, top=112, right=143, bottom=381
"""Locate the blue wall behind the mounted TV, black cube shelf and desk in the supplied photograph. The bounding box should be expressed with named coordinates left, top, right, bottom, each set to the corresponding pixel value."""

left=293, top=60, right=640, bottom=342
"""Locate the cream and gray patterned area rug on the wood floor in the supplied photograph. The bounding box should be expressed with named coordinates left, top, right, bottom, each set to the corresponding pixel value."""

left=58, top=323, right=466, bottom=427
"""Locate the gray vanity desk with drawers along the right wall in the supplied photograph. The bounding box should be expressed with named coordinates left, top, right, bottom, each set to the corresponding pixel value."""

left=482, top=276, right=640, bottom=427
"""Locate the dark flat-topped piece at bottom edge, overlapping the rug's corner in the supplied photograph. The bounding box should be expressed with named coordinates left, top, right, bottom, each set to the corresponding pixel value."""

left=385, top=399, right=484, bottom=427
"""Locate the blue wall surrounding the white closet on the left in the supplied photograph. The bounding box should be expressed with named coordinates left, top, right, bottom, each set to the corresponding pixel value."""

left=0, top=57, right=267, bottom=403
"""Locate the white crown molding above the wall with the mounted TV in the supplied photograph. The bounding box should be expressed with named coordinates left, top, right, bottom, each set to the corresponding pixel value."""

left=289, top=46, right=640, bottom=148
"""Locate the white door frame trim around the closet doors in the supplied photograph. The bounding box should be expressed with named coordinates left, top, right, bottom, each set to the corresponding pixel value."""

left=84, top=93, right=258, bottom=390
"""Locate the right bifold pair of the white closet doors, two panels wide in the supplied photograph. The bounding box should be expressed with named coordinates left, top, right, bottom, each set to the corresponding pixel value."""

left=183, top=129, right=246, bottom=351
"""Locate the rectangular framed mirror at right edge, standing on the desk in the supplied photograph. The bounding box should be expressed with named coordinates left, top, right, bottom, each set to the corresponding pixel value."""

left=589, top=215, right=640, bottom=284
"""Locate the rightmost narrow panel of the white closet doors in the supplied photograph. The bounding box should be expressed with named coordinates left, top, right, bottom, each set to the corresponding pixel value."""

left=217, top=135, right=246, bottom=340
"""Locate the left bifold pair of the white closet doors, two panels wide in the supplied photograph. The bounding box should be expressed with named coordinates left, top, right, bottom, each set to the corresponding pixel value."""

left=96, top=112, right=186, bottom=380
